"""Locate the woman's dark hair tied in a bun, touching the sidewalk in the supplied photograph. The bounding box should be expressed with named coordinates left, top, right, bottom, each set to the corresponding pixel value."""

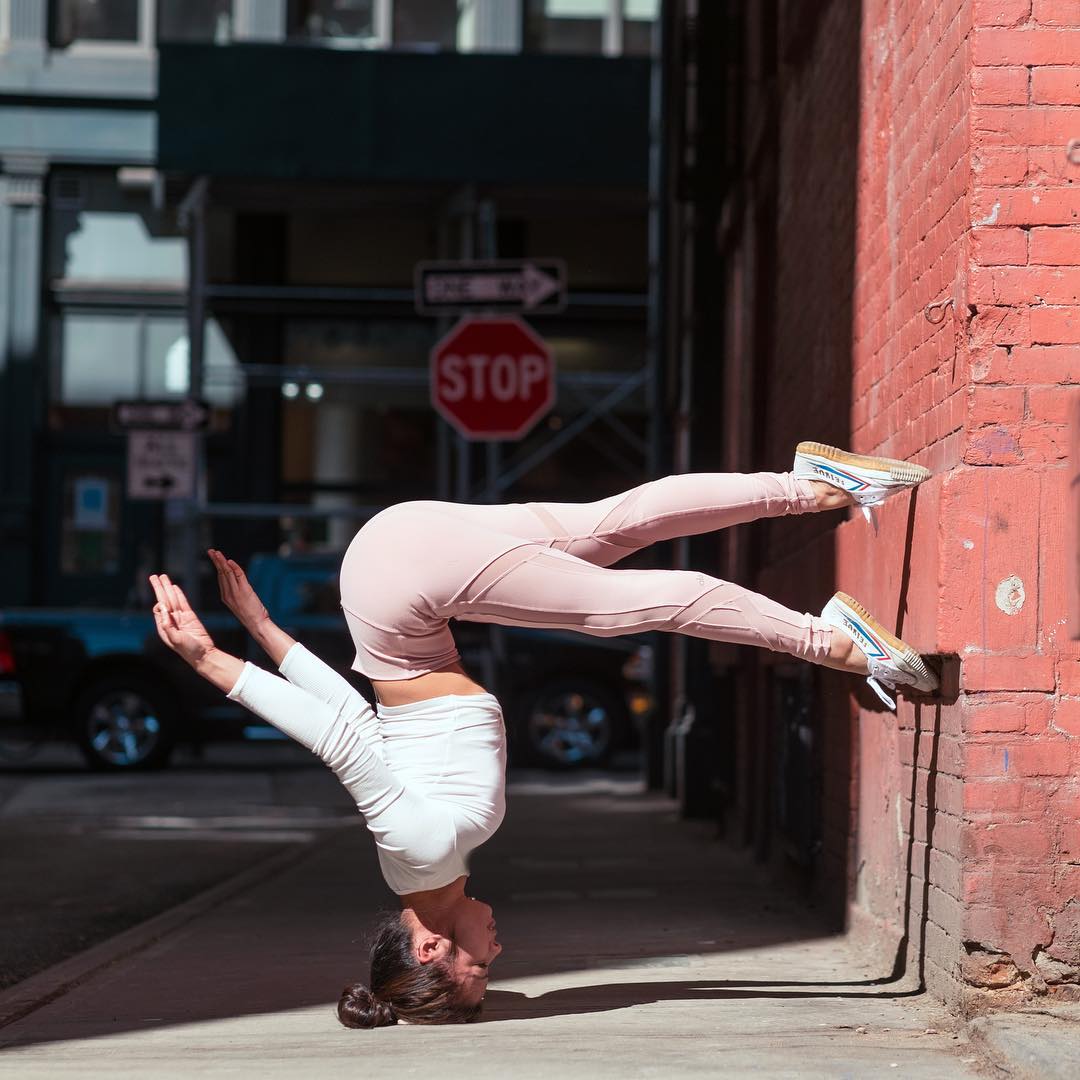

left=338, top=913, right=482, bottom=1027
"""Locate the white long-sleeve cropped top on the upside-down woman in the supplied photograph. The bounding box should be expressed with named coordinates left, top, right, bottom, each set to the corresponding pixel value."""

left=229, top=644, right=507, bottom=894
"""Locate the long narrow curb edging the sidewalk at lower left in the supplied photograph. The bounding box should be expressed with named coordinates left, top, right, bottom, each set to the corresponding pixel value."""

left=0, top=833, right=333, bottom=1028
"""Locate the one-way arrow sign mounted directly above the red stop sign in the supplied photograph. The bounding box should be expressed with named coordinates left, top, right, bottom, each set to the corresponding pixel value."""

left=415, top=259, right=566, bottom=315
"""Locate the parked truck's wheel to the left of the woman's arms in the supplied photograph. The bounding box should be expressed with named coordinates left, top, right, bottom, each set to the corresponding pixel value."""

left=75, top=674, right=176, bottom=771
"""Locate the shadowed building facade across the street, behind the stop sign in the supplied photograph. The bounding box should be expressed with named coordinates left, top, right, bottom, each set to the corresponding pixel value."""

left=0, top=0, right=656, bottom=606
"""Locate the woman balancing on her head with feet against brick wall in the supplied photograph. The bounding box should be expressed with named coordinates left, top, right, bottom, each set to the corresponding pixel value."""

left=150, top=443, right=937, bottom=1027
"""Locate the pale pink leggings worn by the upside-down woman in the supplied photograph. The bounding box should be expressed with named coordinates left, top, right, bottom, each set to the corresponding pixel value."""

left=341, top=473, right=832, bottom=679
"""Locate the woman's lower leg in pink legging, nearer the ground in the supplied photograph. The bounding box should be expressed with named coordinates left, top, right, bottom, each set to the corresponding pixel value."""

left=454, top=546, right=851, bottom=672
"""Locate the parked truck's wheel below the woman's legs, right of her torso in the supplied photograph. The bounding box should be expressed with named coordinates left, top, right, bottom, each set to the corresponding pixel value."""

left=522, top=679, right=626, bottom=769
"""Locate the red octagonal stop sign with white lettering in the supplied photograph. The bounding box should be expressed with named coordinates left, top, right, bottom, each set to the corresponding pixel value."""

left=431, top=315, right=555, bottom=440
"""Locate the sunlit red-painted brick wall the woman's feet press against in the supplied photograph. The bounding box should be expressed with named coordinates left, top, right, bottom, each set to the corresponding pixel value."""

left=732, top=0, right=1080, bottom=1000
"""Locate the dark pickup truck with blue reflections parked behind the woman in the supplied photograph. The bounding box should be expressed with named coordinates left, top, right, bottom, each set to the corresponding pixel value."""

left=0, top=555, right=651, bottom=770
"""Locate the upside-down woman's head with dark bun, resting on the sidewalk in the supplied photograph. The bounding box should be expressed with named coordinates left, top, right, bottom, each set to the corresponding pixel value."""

left=338, top=896, right=502, bottom=1027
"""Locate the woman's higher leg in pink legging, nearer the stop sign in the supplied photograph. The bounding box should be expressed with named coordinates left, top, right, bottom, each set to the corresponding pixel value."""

left=450, top=473, right=816, bottom=566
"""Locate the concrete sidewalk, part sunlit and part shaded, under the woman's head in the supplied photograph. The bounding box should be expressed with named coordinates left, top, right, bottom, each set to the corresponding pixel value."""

left=0, top=782, right=987, bottom=1080
